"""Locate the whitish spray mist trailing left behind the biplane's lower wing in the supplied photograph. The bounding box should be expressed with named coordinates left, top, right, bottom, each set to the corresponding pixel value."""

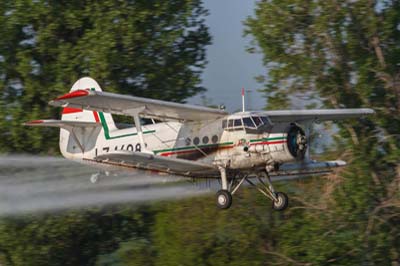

left=0, top=155, right=209, bottom=216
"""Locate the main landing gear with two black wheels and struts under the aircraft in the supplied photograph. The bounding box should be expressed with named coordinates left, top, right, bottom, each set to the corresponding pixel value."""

left=217, top=167, right=289, bottom=211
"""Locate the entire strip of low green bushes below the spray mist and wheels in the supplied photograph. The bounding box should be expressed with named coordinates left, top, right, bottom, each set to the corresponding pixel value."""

left=0, top=190, right=285, bottom=265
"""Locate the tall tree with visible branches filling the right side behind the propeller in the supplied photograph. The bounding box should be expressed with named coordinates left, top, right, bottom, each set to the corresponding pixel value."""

left=246, top=0, right=400, bottom=265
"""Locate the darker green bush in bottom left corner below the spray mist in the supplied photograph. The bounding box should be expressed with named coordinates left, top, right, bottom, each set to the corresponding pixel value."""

left=0, top=209, right=155, bottom=265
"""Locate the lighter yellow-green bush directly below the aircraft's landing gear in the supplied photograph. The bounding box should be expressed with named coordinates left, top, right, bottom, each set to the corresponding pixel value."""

left=153, top=192, right=265, bottom=265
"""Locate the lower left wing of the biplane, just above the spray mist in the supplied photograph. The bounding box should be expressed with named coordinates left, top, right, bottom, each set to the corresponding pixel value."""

left=90, top=151, right=219, bottom=177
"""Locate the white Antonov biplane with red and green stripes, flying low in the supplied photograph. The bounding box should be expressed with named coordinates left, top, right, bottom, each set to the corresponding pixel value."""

left=26, top=77, right=374, bottom=210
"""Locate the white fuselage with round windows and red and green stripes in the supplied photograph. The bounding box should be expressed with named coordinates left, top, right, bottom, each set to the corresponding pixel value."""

left=60, top=111, right=304, bottom=169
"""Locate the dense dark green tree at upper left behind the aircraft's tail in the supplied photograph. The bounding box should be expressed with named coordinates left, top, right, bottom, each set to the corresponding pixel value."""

left=0, top=0, right=210, bottom=153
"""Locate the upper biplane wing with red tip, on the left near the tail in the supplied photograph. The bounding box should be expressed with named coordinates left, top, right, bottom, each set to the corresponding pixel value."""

left=50, top=90, right=228, bottom=121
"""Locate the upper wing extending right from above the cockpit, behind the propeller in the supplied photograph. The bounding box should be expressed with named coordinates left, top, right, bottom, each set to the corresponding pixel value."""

left=262, top=108, right=375, bottom=123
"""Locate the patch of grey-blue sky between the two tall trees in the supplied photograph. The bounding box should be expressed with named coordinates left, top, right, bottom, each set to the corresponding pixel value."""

left=188, top=0, right=266, bottom=112
